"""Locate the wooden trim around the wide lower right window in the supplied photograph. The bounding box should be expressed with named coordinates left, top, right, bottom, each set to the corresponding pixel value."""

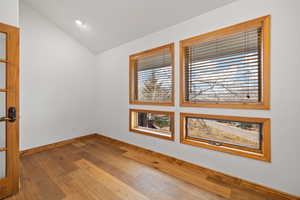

left=180, top=113, right=271, bottom=162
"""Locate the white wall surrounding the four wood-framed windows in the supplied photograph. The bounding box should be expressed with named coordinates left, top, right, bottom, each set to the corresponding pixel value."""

left=97, top=0, right=300, bottom=195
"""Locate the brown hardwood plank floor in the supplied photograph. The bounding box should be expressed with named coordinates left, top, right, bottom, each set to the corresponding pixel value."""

left=7, top=137, right=292, bottom=200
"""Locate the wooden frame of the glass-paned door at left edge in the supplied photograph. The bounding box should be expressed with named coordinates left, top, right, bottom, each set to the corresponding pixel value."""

left=0, top=23, right=20, bottom=199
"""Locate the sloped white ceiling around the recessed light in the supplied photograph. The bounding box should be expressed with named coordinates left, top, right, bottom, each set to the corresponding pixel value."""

left=23, top=0, right=234, bottom=53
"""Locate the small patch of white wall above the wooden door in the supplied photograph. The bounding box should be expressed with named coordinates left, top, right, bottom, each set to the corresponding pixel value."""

left=0, top=0, right=19, bottom=27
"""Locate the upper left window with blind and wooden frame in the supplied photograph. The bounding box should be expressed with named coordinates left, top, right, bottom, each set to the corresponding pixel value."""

left=129, top=44, right=174, bottom=106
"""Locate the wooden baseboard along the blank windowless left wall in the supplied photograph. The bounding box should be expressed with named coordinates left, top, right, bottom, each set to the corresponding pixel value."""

left=20, top=134, right=97, bottom=156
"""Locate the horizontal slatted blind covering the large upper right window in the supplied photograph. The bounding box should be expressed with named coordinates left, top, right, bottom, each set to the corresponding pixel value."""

left=184, top=27, right=262, bottom=103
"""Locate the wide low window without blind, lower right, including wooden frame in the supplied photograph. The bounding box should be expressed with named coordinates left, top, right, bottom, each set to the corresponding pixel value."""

left=180, top=113, right=271, bottom=162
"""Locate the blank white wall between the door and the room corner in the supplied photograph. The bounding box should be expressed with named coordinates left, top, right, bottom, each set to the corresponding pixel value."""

left=20, top=3, right=96, bottom=149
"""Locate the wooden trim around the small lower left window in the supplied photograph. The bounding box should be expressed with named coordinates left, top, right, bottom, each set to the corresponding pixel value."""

left=129, top=109, right=175, bottom=141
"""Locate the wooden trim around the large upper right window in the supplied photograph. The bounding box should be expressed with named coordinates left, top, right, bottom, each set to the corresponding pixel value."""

left=180, top=15, right=270, bottom=110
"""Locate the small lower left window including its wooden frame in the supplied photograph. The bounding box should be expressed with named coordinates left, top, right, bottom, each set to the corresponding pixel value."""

left=129, top=109, right=174, bottom=140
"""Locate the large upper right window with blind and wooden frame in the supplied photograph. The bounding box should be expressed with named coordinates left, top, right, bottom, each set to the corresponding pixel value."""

left=180, top=16, right=270, bottom=109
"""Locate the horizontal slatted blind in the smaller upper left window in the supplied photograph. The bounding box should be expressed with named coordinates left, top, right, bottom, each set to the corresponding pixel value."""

left=136, top=51, right=173, bottom=102
